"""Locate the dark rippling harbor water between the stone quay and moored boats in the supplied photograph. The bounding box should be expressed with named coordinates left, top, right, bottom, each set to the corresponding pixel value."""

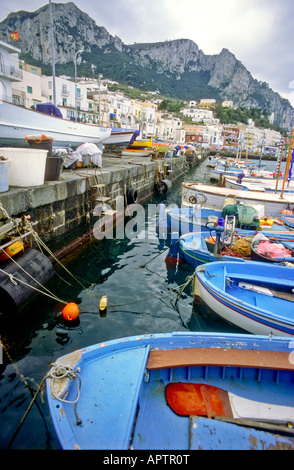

left=0, top=157, right=288, bottom=450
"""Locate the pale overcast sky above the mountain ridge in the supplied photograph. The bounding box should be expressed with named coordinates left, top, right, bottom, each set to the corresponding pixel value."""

left=0, top=0, right=294, bottom=106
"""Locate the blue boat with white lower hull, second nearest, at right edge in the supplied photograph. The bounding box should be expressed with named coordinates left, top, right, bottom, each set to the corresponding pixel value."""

left=194, top=261, right=294, bottom=337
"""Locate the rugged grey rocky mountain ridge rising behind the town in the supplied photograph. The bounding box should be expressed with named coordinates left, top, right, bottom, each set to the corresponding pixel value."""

left=0, top=2, right=294, bottom=130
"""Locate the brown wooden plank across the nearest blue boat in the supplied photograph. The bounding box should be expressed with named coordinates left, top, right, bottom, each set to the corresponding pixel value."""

left=146, top=348, right=294, bottom=370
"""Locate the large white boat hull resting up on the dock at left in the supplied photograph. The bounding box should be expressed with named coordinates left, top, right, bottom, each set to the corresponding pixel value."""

left=0, top=101, right=111, bottom=147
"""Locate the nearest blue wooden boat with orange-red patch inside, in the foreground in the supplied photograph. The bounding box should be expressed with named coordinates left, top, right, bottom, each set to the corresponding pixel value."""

left=47, top=332, right=294, bottom=450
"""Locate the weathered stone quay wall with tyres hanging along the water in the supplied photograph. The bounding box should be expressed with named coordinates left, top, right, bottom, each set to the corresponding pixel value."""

left=0, top=154, right=204, bottom=254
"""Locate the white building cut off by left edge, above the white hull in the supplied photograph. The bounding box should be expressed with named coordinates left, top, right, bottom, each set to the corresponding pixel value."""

left=0, top=41, right=22, bottom=102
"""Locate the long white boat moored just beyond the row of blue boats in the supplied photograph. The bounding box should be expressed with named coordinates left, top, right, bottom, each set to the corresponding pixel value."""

left=182, top=183, right=294, bottom=214
